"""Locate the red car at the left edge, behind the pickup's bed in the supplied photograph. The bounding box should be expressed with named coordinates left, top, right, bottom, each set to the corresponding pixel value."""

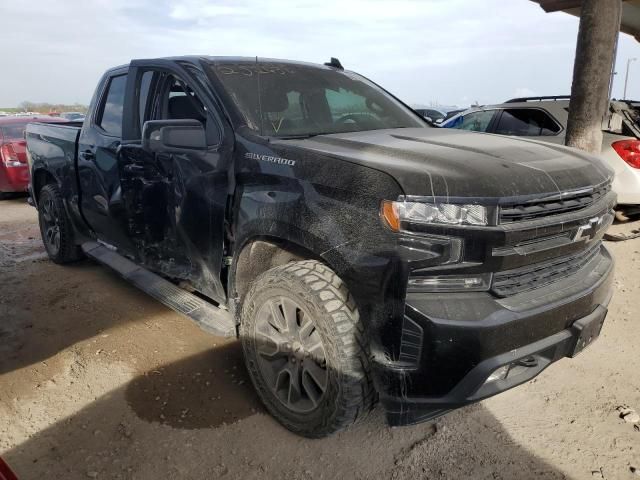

left=0, top=115, right=66, bottom=198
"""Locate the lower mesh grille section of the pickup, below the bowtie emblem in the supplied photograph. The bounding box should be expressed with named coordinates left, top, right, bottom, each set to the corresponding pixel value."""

left=491, top=243, right=600, bottom=297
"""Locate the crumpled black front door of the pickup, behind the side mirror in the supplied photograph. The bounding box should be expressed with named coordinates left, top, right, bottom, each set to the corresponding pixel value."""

left=118, top=66, right=232, bottom=301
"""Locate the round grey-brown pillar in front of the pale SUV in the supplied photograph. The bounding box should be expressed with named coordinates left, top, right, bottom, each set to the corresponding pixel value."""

left=565, top=0, right=622, bottom=153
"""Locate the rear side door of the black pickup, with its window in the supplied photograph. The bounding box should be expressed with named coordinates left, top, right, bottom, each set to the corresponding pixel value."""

left=78, top=68, right=138, bottom=254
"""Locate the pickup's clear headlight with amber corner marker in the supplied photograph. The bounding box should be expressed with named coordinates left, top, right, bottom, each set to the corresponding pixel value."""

left=381, top=200, right=487, bottom=232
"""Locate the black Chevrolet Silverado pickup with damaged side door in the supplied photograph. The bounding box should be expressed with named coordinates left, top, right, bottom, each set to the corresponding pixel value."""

left=27, top=57, right=616, bottom=437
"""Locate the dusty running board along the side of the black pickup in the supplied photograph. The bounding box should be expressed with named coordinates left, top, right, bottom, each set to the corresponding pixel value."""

left=82, top=242, right=236, bottom=337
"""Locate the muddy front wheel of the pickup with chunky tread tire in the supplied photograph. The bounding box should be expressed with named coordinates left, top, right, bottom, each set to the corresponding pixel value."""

left=240, top=260, right=376, bottom=438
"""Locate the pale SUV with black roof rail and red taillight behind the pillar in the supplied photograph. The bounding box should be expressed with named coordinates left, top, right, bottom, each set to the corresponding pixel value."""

left=441, top=96, right=640, bottom=218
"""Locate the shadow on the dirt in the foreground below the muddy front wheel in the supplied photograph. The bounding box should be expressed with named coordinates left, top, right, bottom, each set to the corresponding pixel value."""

left=5, top=342, right=567, bottom=480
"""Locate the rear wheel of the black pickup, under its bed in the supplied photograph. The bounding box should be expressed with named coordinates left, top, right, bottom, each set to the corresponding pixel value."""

left=38, top=184, right=83, bottom=264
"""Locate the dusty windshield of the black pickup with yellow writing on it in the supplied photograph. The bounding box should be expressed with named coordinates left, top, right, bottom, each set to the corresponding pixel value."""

left=210, top=62, right=425, bottom=137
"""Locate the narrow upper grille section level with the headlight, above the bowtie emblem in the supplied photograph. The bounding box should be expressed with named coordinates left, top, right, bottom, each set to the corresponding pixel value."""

left=500, top=183, right=611, bottom=223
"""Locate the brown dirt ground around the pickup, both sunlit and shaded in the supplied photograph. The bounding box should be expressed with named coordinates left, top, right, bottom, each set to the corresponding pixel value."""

left=0, top=198, right=640, bottom=480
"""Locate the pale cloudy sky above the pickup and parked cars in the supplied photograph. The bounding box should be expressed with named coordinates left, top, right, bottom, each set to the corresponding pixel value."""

left=0, top=0, right=640, bottom=107
